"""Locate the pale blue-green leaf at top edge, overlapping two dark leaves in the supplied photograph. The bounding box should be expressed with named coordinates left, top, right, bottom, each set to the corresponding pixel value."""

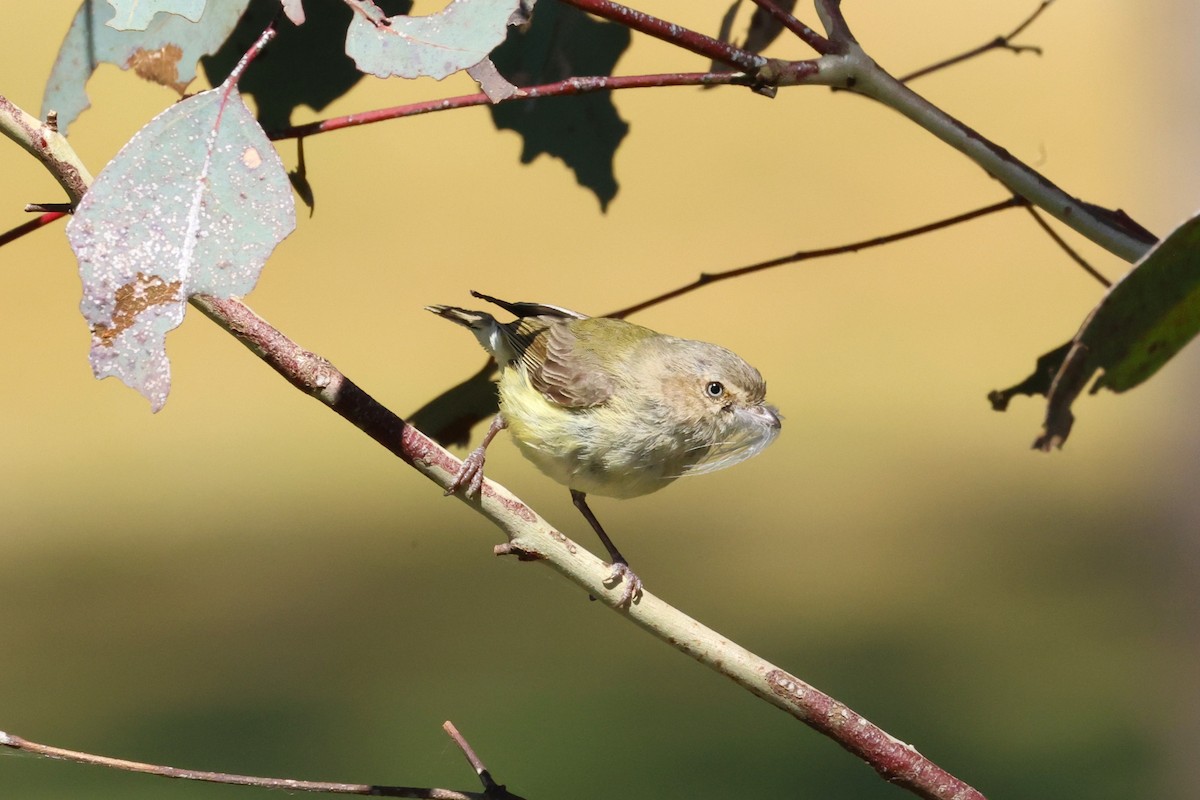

left=346, top=0, right=521, bottom=80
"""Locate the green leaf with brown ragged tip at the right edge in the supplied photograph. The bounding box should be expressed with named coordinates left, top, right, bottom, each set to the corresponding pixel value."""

left=1034, top=215, right=1200, bottom=450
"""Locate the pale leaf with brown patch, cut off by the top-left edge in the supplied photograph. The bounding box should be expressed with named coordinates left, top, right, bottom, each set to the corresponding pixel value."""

left=42, top=0, right=250, bottom=133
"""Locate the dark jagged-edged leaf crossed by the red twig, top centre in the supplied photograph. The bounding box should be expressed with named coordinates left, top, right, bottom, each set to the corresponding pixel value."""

left=491, top=2, right=630, bottom=209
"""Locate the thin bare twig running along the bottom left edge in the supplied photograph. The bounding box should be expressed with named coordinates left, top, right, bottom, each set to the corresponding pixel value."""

left=0, top=730, right=522, bottom=800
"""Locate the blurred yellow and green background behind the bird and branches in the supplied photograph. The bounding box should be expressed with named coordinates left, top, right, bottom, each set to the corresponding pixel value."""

left=0, top=0, right=1200, bottom=800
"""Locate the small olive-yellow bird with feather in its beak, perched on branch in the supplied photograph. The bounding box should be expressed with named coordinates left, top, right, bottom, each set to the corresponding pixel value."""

left=426, top=291, right=780, bottom=606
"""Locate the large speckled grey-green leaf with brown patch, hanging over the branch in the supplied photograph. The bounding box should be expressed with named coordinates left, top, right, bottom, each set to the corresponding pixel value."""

left=67, top=85, right=295, bottom=411
